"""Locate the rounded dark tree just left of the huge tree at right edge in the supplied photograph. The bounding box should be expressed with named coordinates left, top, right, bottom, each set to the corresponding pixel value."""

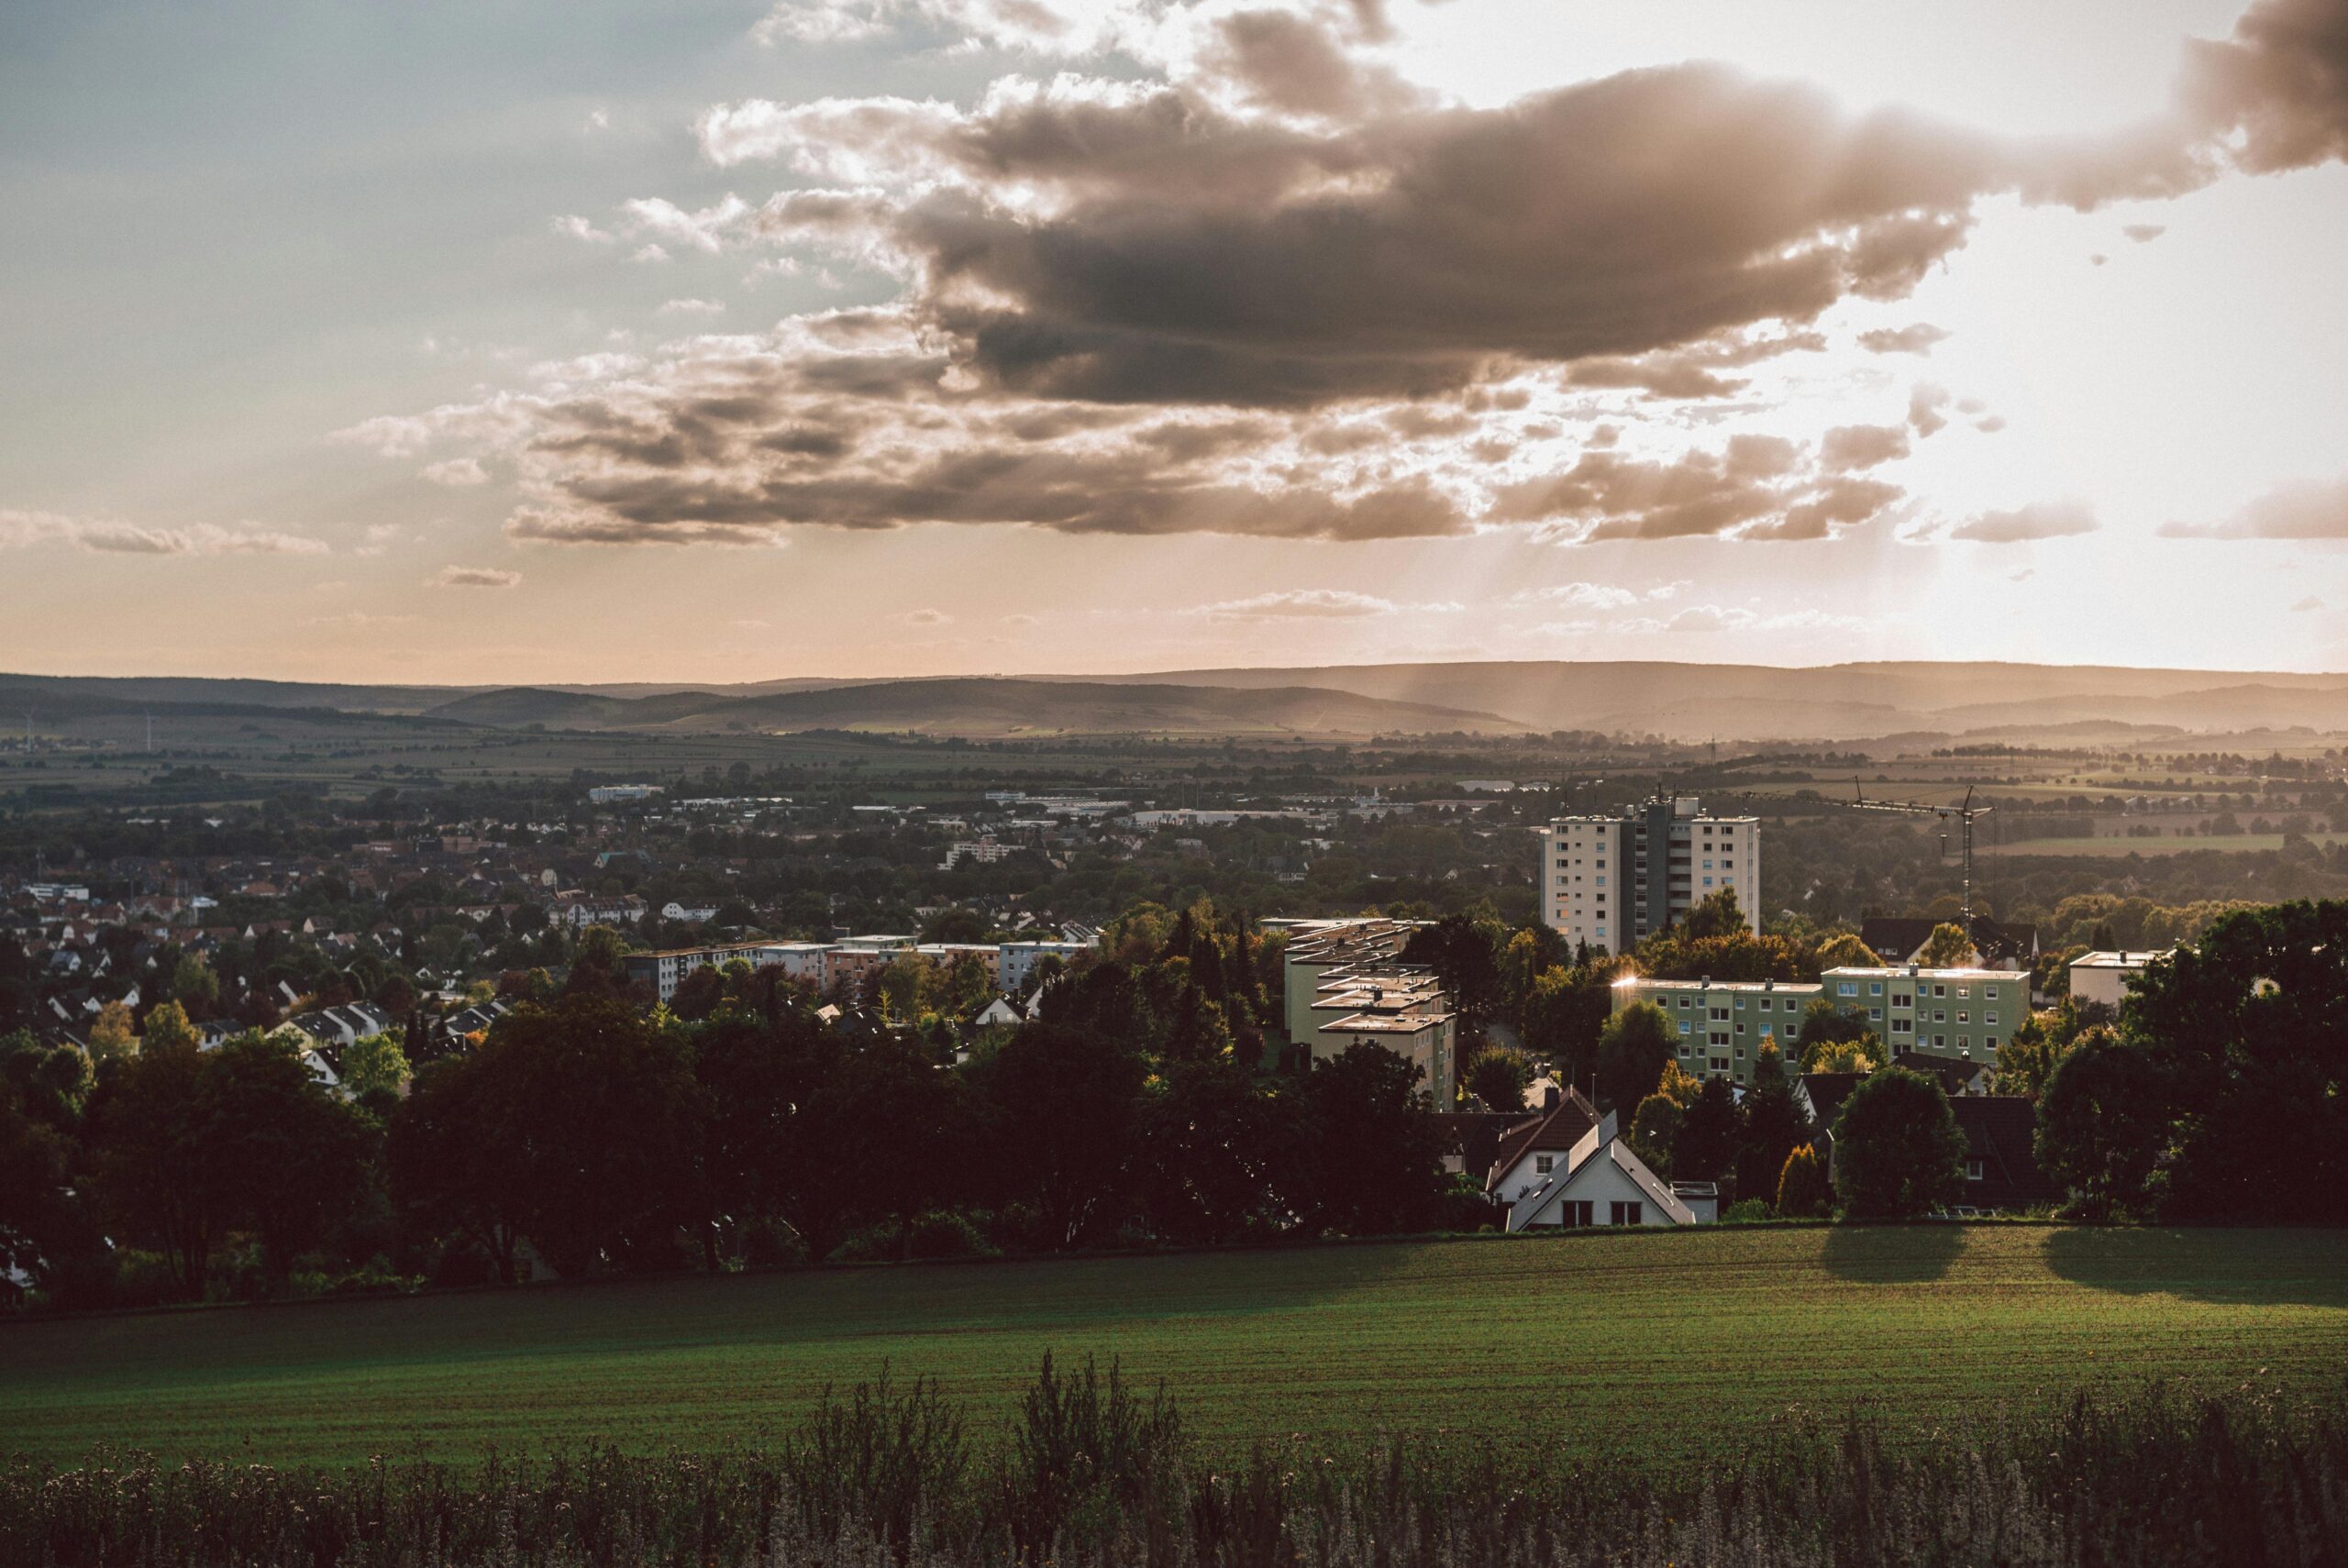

left=2038, top=1031, right=2167, bottom=1220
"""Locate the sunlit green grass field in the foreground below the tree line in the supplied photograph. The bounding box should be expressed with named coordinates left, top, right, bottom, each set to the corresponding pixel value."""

left=0, top=1225, right=2348, bottom=1463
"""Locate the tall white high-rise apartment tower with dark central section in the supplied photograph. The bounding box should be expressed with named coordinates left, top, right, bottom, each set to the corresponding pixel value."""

left=1534, top=796, right=1761, bottom=953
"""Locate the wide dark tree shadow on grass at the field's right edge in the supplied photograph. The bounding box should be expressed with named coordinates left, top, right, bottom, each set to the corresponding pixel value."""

left=2045, top=1225, right=2348, bottom=1308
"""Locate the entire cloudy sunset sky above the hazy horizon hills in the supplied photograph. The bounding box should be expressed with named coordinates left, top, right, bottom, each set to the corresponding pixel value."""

left=0, top=0, right=2348, bottom=683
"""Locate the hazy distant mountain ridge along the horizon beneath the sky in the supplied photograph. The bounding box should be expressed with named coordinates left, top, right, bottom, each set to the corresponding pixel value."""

left=0, top=659, right=2348, bottom=744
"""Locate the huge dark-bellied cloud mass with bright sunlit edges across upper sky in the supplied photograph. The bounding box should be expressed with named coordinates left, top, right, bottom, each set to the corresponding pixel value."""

left=352, top=0, right=2334, bottom=545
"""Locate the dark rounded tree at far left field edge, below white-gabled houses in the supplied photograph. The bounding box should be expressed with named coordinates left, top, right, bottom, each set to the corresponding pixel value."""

left=194, top=1035, right=373, bottom=1286
